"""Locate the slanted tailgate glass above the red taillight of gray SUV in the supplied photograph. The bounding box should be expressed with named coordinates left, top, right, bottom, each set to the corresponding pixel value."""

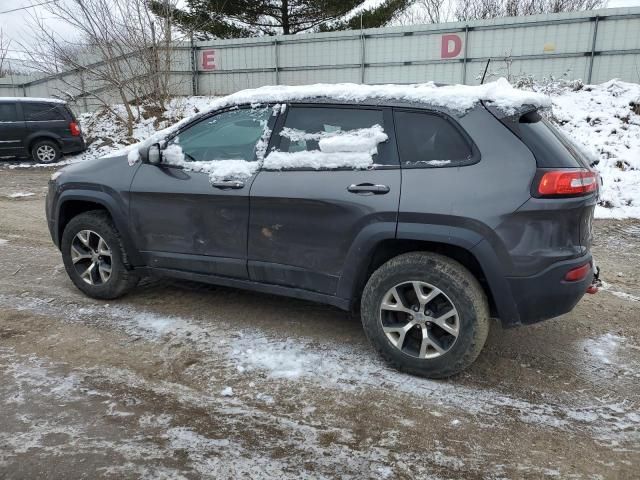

left=515, top=111, right=585, bottom=168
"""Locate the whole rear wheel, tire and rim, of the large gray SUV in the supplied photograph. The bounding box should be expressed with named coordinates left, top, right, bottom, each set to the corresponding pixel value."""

left=361, top=252, right=489, bottom=378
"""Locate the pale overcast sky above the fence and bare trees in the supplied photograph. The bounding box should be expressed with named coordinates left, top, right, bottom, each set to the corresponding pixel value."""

left=0, top=0, right=640, bottom=65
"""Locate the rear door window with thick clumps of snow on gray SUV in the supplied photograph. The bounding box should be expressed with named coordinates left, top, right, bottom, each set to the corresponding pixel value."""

left=264, top=106, right=389, bottom=170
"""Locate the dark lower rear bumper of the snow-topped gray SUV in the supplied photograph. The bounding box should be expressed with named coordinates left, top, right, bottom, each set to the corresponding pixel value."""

left=501, top=254, right=594, bottom=327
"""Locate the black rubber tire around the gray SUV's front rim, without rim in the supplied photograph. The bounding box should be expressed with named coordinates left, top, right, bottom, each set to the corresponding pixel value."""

left=60, top=210, right=139, bottom=300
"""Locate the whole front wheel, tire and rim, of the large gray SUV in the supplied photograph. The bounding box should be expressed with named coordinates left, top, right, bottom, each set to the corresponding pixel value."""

left=61, top=211, right=138, bottom=299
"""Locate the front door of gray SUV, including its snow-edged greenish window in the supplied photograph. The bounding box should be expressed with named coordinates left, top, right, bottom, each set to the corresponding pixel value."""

left=130, top=106, right=275, bottom=278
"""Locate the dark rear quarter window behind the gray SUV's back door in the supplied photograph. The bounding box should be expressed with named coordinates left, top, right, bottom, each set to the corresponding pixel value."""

left=394, top=111, right=473, bottom=167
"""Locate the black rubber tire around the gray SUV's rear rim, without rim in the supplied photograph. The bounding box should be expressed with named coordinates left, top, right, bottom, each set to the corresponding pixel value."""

left=361, top=252, right=489, bottom=378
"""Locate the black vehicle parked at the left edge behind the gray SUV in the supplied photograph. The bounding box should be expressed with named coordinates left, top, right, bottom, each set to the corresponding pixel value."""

left=0, top=97, right=86, bottom=163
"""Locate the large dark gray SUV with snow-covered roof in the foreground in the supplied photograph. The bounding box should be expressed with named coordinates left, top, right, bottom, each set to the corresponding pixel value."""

left=46, top=88, right=598, bottom=378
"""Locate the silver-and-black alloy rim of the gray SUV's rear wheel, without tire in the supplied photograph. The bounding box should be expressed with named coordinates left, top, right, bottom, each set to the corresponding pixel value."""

left=380, top=281, right=460, bottom=359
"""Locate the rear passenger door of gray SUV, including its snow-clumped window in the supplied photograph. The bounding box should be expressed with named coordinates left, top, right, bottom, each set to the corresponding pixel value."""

left=248, top=104, right=401, bottom=295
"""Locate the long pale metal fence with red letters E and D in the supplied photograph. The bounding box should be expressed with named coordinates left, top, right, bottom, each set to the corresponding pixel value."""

left=0, top=7, right=640, bottom=110
